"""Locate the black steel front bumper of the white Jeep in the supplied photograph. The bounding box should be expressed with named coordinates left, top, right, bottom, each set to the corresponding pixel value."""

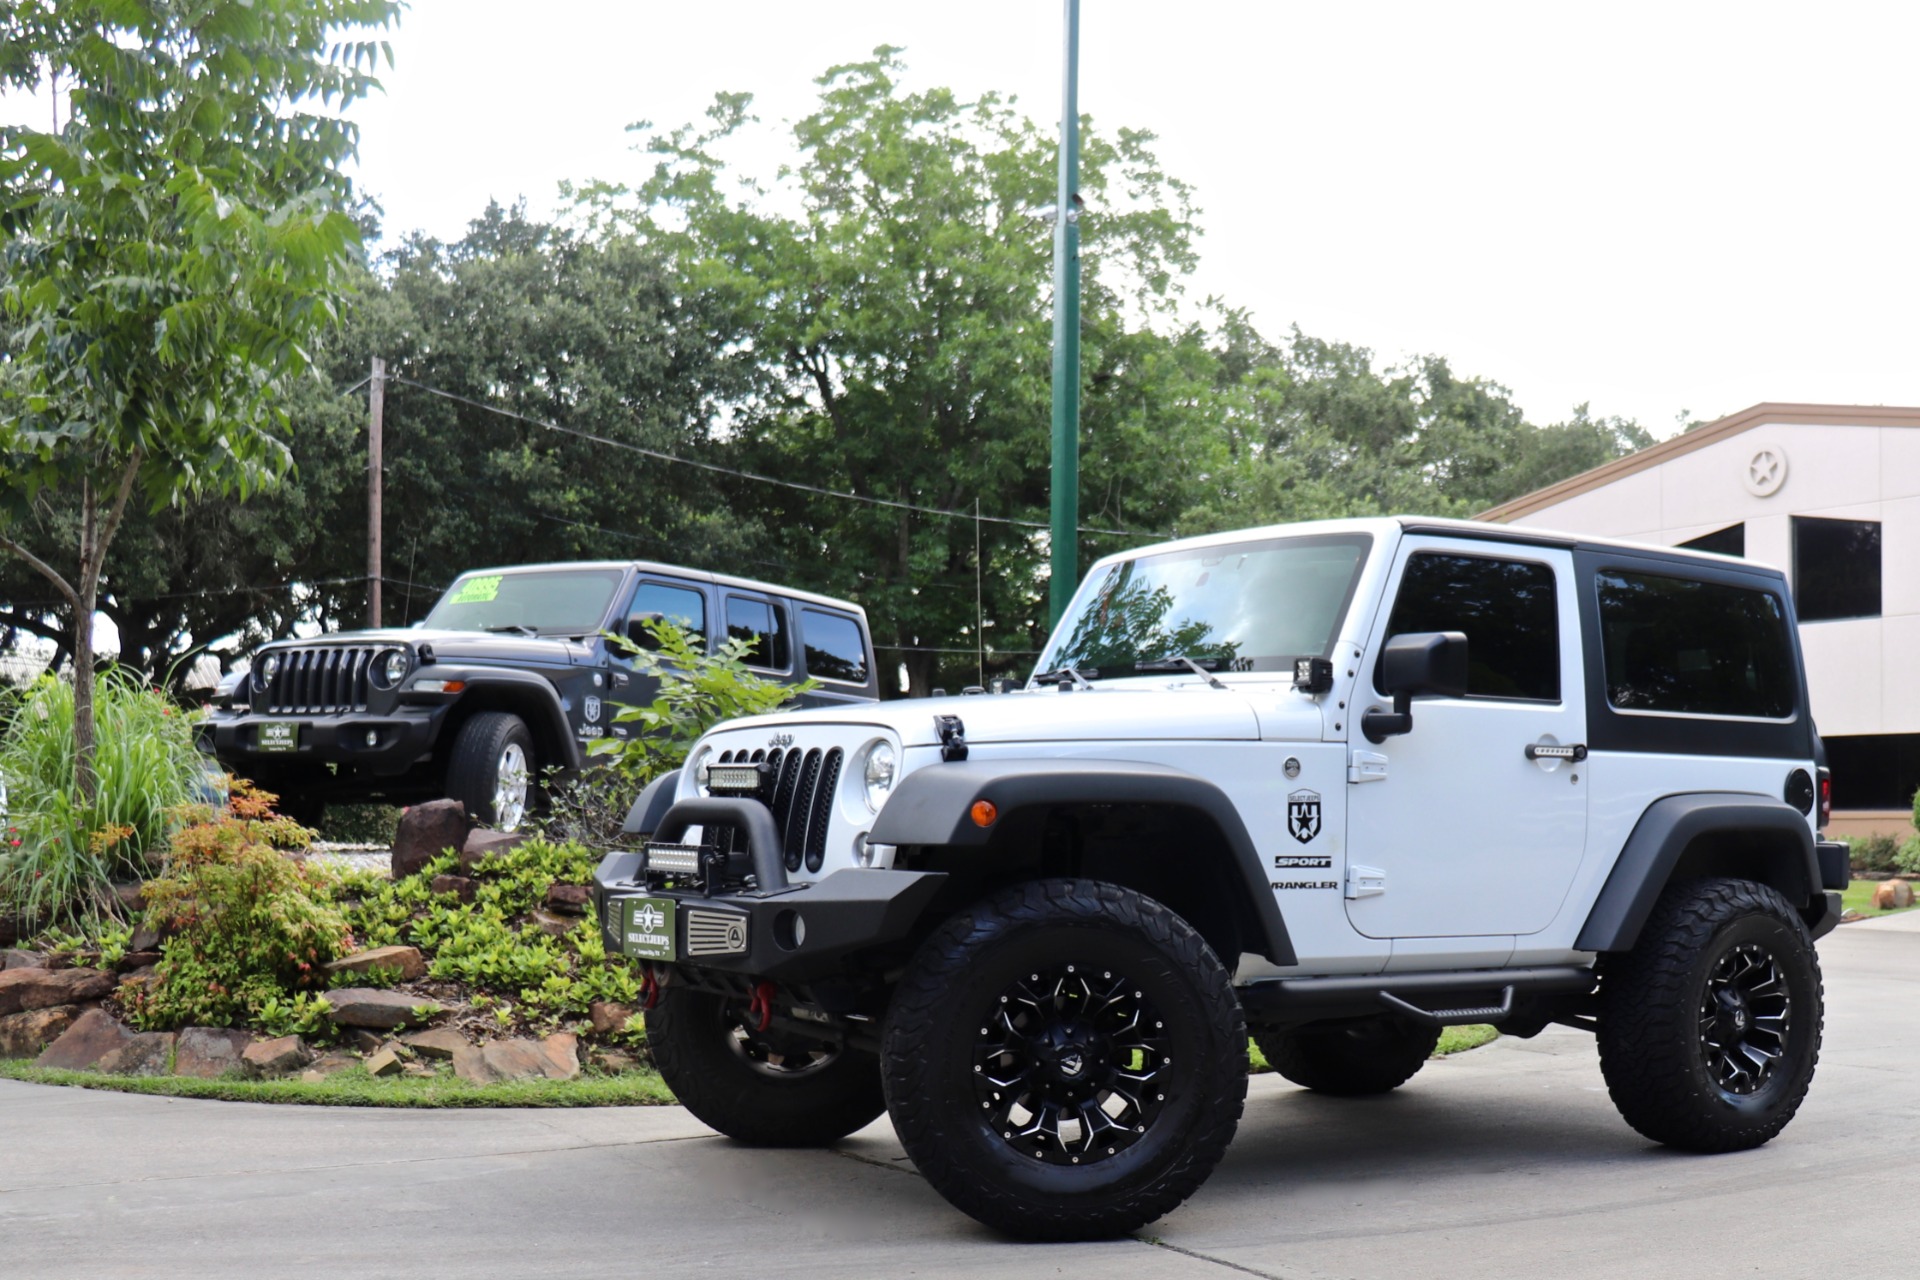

left=593, top=852, right=947, bottom=983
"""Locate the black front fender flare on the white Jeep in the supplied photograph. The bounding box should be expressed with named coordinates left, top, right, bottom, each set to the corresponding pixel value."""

left=868, top=758, right=1298, bottom=965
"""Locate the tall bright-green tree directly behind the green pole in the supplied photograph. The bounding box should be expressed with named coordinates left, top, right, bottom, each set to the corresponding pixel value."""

left=584, top=48, right=1212, bottom=693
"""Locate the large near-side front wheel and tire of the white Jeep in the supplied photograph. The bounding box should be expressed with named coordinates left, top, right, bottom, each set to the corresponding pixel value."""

left=881, top=879, right=1246, bottom=1240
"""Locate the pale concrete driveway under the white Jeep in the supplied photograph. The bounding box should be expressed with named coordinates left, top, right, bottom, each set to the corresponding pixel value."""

left=0, top=912, right=1920, bottom=1280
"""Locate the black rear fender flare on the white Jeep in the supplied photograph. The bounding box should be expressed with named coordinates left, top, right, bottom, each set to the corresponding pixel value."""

left=1574, top=791, right=1822, bottom=952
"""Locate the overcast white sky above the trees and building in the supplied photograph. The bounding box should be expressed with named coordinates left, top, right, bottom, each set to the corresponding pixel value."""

left=11, top=0, right=1920, bottom=436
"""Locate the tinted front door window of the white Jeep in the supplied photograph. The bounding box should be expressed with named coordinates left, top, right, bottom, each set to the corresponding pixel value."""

left=1373, top=551, right=1559, bottom=702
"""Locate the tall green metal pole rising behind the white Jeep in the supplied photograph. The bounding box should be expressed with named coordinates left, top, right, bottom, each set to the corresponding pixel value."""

left=1048, top=0, right=1079, bottom=628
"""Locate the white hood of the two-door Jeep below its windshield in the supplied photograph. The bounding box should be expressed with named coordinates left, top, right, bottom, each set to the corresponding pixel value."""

left=720, top=677, right=1273, bottom=747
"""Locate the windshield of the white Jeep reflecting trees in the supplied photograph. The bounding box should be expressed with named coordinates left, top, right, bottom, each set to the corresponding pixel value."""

left=1041, top=533, right=1373, bottom=679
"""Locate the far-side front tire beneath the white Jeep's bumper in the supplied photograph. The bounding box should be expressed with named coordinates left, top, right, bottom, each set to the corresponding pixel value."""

left=647, top=986, right=887, bottom=1148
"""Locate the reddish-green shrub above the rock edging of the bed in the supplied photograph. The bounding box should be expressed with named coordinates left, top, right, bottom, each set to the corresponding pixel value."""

left=123, top=785, right=353, bottom=1031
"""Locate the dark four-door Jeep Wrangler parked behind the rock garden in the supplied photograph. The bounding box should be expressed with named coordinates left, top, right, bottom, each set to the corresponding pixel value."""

left=200, top=560, right=879, bottom=831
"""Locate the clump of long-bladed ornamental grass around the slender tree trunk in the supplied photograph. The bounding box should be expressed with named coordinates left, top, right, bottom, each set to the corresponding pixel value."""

left=0, top=670, right=205, bottom=925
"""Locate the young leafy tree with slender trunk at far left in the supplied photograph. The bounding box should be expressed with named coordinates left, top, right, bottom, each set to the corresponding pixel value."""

left=0, top=0, right=399, bottom=798
